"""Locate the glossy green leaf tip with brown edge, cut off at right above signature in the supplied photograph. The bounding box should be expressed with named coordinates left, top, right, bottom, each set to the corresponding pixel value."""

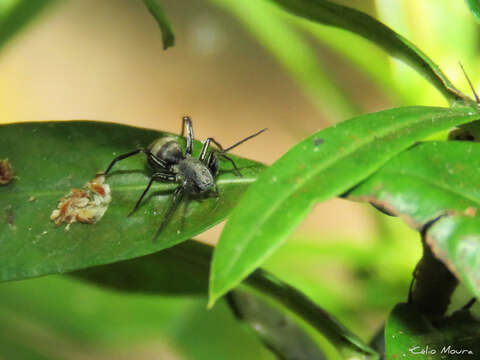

left=426, top=217, right=480, bottom=299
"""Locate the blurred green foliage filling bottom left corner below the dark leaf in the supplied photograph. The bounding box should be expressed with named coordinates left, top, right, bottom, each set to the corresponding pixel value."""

left=0, top=276, right=274, bottom=360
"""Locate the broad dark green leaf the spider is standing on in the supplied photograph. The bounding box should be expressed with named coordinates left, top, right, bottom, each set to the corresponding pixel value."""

left=0, top=121, right=264, bottom=281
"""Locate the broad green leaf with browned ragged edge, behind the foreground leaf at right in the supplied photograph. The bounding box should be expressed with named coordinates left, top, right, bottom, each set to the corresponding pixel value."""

left=348, top=141, right=480, bottom=230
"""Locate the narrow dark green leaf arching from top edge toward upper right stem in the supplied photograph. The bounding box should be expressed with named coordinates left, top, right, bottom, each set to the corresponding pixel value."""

left=270, top=0, right=466, bottom=104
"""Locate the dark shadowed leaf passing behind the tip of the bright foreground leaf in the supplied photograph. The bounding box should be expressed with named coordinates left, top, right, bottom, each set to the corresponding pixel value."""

left=72, top=241, right=374, bottom=359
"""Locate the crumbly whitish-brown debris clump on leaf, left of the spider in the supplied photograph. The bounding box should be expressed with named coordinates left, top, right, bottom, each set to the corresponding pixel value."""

left=50, top=174, right=112, bottom=231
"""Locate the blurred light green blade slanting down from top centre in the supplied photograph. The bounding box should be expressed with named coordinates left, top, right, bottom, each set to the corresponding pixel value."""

left=212, top=0, right=359, bottom=122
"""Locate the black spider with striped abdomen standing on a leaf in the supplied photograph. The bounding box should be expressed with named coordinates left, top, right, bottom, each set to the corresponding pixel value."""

left=105, top=116, right=267, bottom=242
